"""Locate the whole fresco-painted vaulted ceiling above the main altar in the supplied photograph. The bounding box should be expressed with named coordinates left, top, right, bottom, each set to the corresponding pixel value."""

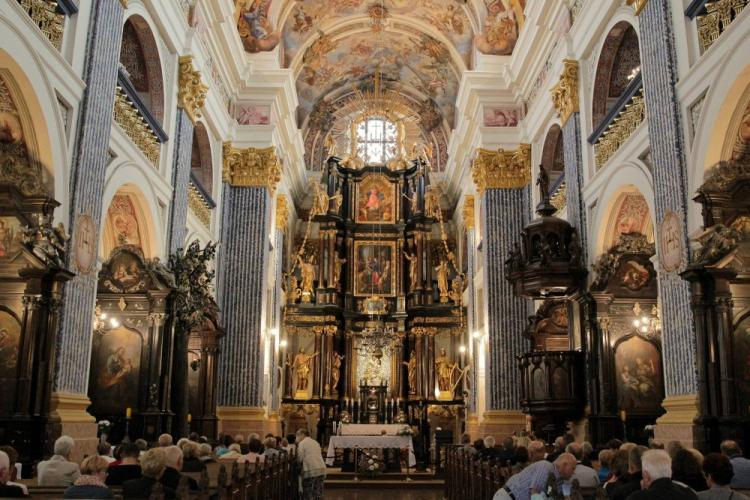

left=235, top=0, right=525, bottom=170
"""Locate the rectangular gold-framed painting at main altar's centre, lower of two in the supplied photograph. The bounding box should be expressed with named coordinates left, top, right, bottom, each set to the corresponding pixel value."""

left=354, top=241, right=396, bottom=297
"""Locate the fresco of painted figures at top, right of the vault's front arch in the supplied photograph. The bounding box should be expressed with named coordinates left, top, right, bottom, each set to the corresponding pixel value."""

left=474, top=0, right=526, bottom=56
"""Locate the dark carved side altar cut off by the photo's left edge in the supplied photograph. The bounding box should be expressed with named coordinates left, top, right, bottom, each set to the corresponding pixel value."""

left=0, top=184, right=73, bottom=462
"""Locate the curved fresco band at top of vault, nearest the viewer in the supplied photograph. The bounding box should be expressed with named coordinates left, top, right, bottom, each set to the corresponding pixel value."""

left=283, top=0, right=474, bottom=66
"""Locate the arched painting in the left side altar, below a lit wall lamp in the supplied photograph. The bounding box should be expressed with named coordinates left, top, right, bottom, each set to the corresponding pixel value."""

left=89, top=326, right=143, bottom=414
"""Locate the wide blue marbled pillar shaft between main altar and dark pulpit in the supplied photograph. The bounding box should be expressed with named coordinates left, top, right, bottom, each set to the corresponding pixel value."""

left=481, top=187, right=531, bottom=410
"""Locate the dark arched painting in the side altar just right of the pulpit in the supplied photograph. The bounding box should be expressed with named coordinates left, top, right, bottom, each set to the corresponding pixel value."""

left=615, top=335, right=664, bottom=413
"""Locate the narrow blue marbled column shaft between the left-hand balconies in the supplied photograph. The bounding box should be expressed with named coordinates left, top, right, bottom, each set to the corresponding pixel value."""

left=167, top=109, right=195, bottom=254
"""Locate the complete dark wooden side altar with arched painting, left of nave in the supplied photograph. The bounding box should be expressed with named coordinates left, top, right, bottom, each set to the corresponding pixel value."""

left=89, top=246, right=174, bottom=442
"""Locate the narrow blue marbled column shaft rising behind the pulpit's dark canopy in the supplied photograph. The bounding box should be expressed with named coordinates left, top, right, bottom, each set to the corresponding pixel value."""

left=562, top=113, right=588, bottom=263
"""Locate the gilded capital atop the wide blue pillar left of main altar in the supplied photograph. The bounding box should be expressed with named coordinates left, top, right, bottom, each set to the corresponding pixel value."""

left=222, top=142, right=281, bottom=193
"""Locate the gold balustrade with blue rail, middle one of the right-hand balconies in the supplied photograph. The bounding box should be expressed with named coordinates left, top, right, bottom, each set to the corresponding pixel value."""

left=588, top=73, right=646, bottom=168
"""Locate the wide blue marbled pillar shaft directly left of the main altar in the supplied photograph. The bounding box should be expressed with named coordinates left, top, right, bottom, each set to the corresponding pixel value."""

left=218, top=184, right=271, bottom=407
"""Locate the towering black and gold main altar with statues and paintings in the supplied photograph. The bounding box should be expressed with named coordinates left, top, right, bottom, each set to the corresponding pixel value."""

left=279, top=117, right=469, bottom=458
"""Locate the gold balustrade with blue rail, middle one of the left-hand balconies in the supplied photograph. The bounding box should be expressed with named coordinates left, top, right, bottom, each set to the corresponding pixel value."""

left=115, top=68, right=168, bottom=167
